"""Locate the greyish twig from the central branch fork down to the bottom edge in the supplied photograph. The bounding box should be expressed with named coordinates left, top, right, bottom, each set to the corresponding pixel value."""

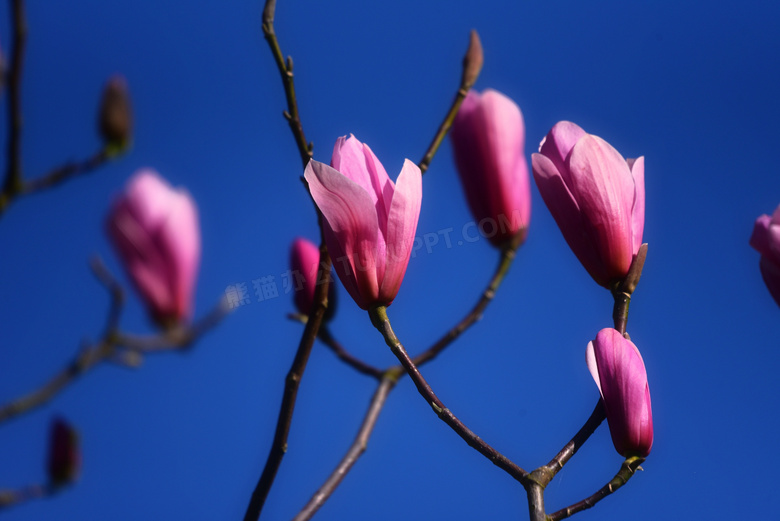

left=293, top=373, right=400, bottom=521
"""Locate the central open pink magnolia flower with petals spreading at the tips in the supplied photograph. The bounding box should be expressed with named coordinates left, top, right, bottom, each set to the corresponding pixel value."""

left=304, top=136, right=422, bottom=309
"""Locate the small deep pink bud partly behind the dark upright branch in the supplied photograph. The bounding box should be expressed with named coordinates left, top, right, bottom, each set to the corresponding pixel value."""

left=290, top=237, right=336, bottom=320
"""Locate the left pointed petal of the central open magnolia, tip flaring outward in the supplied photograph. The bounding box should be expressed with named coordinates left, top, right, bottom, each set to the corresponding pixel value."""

left=304, top=160, right=379, bottom=307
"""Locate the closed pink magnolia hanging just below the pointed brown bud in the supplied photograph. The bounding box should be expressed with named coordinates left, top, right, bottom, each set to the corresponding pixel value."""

left=450, top=89, right=531, bottom=246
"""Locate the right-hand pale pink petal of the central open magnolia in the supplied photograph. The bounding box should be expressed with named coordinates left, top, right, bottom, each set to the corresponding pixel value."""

left=379, top=159, right=422, bottom=305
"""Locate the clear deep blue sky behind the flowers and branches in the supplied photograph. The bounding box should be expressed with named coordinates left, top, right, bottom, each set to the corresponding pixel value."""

left=0, top=0, right=780, bottom=521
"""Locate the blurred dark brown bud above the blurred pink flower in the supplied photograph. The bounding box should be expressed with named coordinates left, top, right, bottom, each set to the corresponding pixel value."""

left=98, top=74, right=133, bottom=154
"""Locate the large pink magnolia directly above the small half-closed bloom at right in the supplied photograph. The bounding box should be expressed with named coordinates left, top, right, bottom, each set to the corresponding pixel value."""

left=531, top=121, right=645, bottom=288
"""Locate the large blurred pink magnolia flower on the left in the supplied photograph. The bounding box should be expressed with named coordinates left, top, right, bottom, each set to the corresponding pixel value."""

left=107, top=170, right=200, bottom=325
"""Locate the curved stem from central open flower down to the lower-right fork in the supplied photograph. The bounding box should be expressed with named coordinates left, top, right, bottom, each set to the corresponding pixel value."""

left=369, top=306, right=528, bottom=483
